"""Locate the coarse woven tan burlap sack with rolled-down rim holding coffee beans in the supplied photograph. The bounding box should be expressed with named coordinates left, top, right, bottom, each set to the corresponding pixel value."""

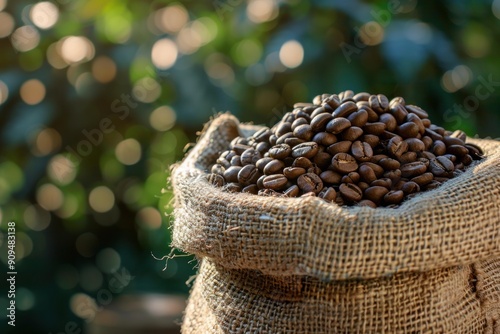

left=172, top=114, right=500, bottom=334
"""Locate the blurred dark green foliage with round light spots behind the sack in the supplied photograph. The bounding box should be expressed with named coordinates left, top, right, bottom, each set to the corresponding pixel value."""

left=0, top=0, right=500, bottom=333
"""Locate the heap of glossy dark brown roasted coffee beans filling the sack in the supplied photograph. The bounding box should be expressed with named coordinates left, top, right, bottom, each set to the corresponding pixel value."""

left=208, top=90, right=483, bottom=208
